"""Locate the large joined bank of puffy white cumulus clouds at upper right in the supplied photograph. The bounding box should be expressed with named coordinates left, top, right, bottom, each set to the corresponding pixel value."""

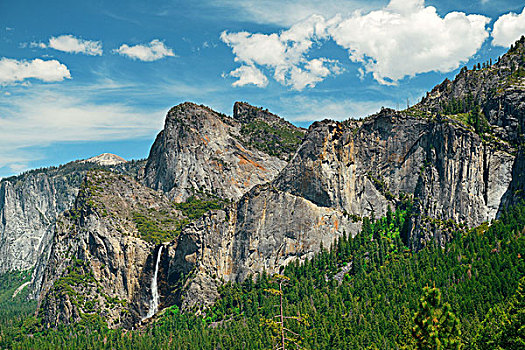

left=221, top=0, right=490, bottom=90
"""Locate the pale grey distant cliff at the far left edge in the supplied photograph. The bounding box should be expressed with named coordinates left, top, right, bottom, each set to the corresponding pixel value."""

left=0, top=162, right=142, bottom=297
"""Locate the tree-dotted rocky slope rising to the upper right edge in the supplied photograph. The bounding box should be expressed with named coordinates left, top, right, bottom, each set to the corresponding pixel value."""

left=414, top=37, right=525, bottom=145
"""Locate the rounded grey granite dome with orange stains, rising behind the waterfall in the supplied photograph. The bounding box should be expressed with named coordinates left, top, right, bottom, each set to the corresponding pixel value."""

left=142, top=103, right=302, bottom=202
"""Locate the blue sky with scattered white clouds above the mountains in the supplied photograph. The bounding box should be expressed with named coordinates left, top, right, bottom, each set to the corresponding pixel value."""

left=0, top=0, right=525, bottom=177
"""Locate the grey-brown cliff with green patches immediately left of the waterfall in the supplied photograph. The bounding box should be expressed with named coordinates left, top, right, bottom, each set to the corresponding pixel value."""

left=39, top=171, right=182, bottom=327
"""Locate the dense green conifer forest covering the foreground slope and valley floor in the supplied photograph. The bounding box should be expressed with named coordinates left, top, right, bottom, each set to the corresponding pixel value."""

left=0, top=205, right=525, bottom=349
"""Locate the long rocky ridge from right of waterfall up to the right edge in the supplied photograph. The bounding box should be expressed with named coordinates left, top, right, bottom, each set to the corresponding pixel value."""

left=154, top=40, right=525, bottom=310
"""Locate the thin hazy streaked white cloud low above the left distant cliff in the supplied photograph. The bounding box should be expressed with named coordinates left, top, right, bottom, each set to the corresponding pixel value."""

left=0, top=84, right=165, bottom=172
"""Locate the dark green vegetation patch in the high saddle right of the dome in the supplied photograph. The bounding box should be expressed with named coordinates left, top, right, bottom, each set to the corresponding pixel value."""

left=241, top=120, right=304, bottom=158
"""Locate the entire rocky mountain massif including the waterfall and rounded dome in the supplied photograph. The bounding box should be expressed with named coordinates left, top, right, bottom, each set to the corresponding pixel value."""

left=0, top=39, right=525, bottom=340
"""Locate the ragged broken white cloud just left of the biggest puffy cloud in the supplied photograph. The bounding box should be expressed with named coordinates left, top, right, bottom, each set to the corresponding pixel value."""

left=221, top=16, right=341, bottom=90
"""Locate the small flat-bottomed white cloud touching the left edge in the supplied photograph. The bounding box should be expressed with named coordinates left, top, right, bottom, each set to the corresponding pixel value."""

left=0, top=57, right=71, bottom=85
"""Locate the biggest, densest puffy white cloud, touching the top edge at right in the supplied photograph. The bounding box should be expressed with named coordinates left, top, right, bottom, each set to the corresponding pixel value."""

left=329, top=0, right=489, bottom=84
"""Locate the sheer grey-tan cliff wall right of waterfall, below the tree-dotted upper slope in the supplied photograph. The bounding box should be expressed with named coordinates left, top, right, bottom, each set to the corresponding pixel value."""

left=170, top=110, right=515, bottom=310
